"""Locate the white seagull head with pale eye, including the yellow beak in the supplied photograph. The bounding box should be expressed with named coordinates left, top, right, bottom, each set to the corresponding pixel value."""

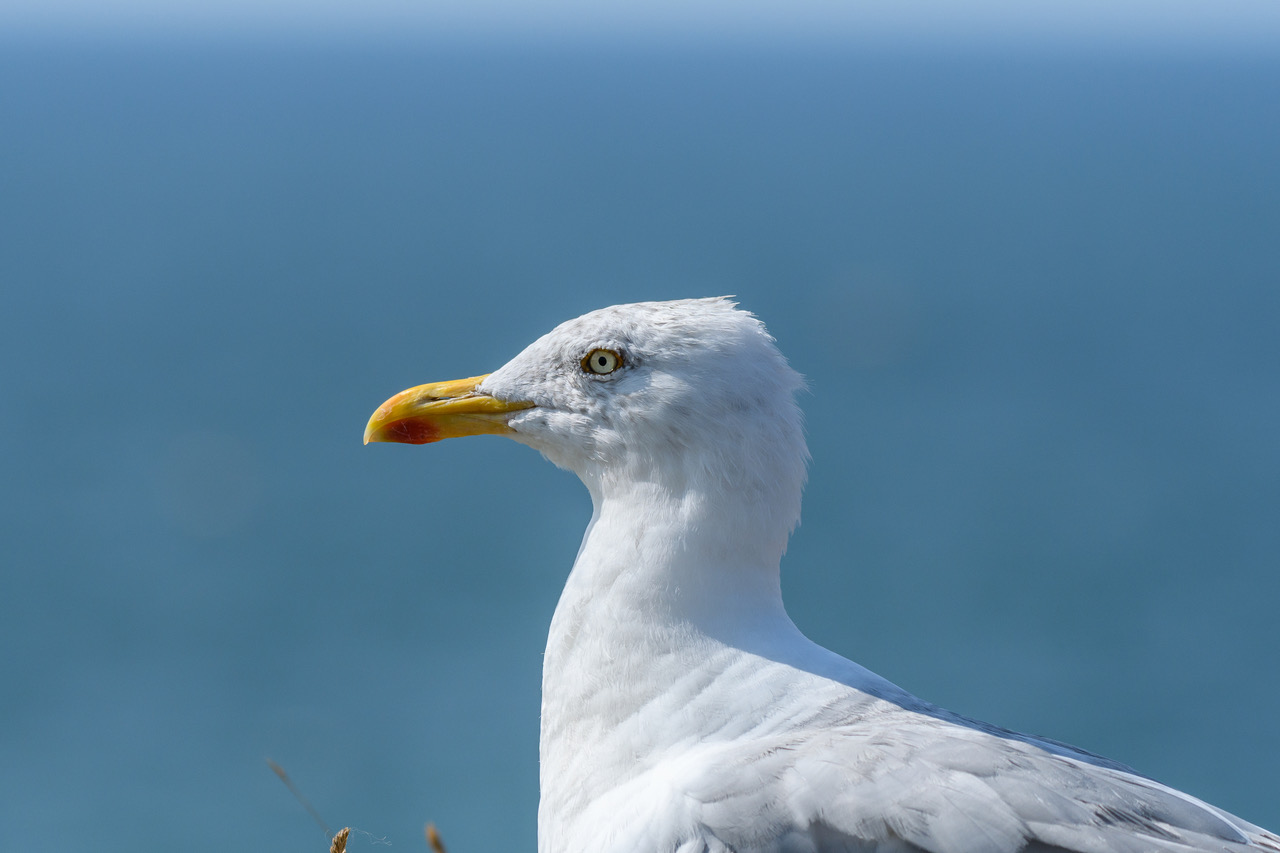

left=365, top=298, right=806, bottom=529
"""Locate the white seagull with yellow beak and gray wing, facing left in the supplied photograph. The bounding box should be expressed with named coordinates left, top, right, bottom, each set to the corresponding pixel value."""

left=365, top=297, right=1280, bottom=853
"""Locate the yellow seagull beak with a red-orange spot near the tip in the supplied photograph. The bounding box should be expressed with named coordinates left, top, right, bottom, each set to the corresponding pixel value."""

left=365, top=374, right=534, bottom=444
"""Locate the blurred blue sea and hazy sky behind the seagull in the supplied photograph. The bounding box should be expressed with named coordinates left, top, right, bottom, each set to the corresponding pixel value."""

left=0, top=0, right=1280, bottom=853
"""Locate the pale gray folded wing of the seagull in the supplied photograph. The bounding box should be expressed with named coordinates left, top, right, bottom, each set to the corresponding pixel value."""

left=668, top=706, right=1280, bottom=853
